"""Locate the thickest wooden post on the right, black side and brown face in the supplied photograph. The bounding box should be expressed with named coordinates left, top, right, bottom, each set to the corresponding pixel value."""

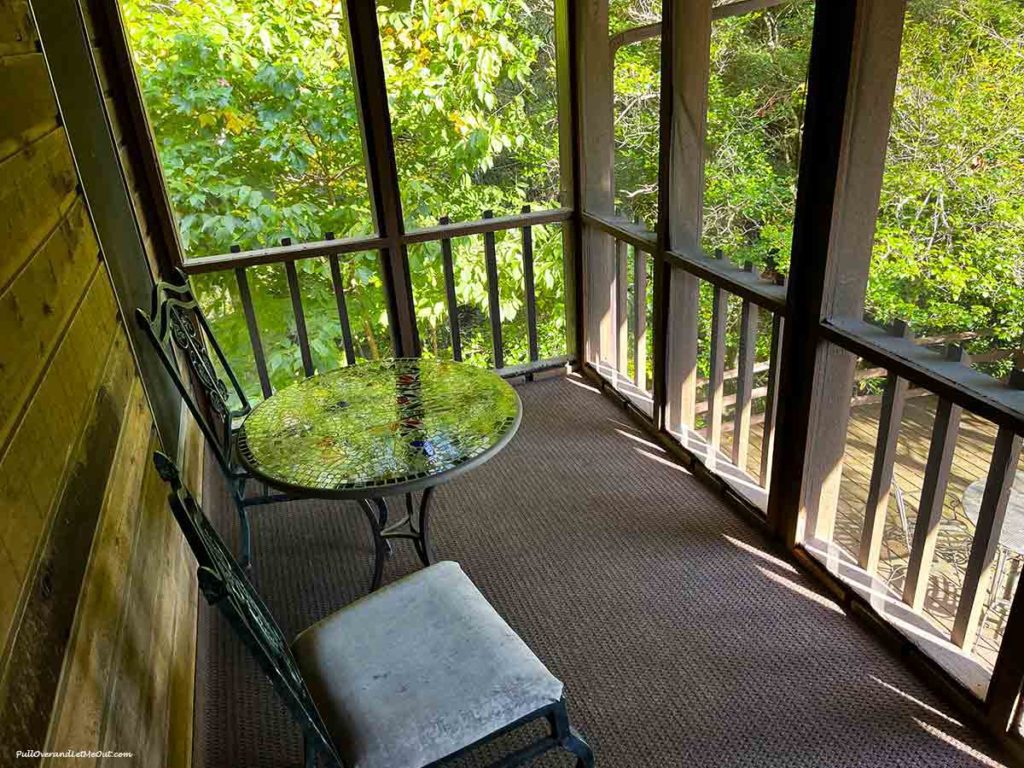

left=768, top=0, right=906, bottom=546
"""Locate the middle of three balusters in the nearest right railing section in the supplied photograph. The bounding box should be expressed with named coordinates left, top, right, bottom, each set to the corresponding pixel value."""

left=903, top=346, right=967, bottom=610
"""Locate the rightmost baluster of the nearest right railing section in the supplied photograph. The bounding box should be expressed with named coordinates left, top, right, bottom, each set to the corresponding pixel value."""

left=950, top=370, right=1024, bottom=651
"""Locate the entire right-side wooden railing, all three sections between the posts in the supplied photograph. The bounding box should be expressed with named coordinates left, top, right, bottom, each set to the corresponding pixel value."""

left=582, top=201, right=1024, bottom=706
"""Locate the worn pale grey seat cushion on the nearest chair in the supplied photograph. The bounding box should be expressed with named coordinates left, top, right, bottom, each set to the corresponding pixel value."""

left=292, top=562, right=562, bottom=768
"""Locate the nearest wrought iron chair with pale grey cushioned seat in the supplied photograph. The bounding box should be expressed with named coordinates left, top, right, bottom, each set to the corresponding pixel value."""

left=154, top=453, right=594, bottom=768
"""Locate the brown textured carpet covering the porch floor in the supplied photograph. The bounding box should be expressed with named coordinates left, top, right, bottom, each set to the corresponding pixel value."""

left=196, top=377, right=1011, bottom=768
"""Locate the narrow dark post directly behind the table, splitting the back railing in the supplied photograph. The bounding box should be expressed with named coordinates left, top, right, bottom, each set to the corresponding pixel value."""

left=346, top=0, right=420, bottom=356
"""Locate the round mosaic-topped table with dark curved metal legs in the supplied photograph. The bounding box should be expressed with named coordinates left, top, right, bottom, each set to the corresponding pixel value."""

left=238, top=358, right=522, bottom=591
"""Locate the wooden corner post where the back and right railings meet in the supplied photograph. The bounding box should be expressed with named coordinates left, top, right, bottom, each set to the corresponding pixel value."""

left=572, top=0, right=615, bottom=365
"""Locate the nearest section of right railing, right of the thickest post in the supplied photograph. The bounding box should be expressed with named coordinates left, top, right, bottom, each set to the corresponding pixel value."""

left=824, top=321, right=1024, bottom=663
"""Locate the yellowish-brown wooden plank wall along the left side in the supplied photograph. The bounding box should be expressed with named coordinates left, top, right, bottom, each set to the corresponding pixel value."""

left=0, top=0, right=200, bottom=766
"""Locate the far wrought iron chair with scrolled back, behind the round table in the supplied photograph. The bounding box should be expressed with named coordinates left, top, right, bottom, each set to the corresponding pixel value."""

left=135, top=270, right=289, bottom=567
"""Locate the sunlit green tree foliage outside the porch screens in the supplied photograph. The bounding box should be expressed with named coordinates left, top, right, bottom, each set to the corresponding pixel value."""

left=123, top=0, right=1024, bottom=397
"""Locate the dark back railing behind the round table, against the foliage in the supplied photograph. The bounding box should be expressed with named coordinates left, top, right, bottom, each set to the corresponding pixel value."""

left=183, top=206, right=570, bottom=397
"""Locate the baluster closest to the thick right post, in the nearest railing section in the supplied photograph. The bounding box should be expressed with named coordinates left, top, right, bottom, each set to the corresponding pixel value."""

left=857, top=321, right=910, bottom=573
